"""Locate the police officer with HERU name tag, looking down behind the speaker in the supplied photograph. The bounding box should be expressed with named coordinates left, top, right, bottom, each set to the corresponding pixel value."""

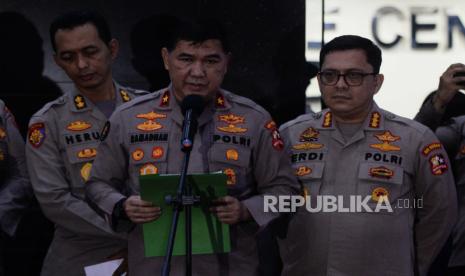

left=26, top=11, right=145, bottom=276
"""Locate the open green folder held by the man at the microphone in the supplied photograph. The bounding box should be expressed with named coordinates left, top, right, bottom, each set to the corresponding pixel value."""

left=139, top=172, right=231, bottom=257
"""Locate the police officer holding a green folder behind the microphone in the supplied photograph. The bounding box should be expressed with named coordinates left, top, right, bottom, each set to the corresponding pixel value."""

left=86, top=20, right=298, bottom=276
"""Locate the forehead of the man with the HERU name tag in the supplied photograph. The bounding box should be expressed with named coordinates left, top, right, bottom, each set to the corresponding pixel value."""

left=55, top=23, right=103, bottom=52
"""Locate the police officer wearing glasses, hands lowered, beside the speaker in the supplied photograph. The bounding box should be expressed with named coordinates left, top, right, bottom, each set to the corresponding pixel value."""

left=280, top=35, right=457, bottom=276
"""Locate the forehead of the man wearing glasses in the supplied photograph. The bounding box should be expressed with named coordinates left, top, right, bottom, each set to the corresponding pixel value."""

left=321, top=49, right=373, bottom=71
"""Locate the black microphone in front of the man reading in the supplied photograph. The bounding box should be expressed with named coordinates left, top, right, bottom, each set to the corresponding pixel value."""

left=181, top=95, right=205, bottom=152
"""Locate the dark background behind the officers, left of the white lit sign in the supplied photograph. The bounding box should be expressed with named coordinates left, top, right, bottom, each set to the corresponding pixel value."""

left=0, top=0, right=315, bottom=275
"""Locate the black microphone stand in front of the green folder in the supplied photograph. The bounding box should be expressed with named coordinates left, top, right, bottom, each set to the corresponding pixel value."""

left=162, top=110, right=200, bottom=276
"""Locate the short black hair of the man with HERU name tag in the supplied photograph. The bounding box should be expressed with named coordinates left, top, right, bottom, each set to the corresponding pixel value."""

left=49, top=10, right=112, bottom=52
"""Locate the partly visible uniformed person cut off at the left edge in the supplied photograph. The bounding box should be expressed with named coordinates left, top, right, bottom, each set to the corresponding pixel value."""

left=0, top=100, right=33, bottom=275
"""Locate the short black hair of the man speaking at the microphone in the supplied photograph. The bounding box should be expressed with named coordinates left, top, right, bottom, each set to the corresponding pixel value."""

left=166, top=18, right=230, bottom=53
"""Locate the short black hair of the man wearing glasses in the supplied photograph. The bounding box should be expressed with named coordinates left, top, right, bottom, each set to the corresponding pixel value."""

left=320, top=35, right=382, bottom=74
